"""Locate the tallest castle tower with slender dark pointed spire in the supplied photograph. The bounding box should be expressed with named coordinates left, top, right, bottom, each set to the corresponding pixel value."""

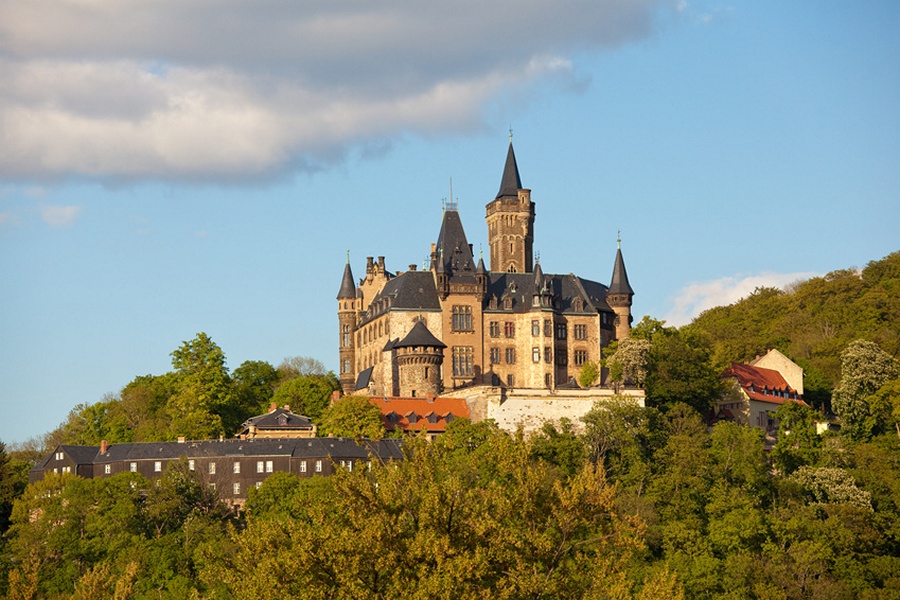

left=485, top=142, right=534, bottom=273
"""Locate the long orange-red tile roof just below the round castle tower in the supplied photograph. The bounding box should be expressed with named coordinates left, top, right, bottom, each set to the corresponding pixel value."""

left=369, top=396, right=469, bottom=433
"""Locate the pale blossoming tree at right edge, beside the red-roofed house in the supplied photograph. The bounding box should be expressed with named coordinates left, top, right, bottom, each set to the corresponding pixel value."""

left=832, top=340, right=898, bottom=440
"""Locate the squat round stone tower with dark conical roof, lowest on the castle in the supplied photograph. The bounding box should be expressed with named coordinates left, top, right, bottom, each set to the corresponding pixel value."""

left=394, top=321, right=447, bottom=398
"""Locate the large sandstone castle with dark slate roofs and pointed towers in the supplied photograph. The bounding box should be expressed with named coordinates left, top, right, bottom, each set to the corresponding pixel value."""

left=337, top=140, right=634, bottom=397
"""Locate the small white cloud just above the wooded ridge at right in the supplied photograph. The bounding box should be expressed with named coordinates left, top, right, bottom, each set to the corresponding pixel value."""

left=665, top=273, right=816, bottom=327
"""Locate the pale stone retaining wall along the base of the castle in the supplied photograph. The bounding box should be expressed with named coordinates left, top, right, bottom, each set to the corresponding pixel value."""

left=454, top=386, right=644, bottom=434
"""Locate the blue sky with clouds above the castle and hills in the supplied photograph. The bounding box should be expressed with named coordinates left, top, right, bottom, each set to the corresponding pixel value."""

left=0, top=0, right=900, bottom=444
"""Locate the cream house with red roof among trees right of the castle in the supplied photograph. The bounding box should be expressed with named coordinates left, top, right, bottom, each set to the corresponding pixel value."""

left=713, top=350, right=805, bottom=435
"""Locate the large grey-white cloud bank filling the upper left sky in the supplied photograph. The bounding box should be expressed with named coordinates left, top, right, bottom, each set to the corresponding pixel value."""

left=0, top=0, right=675, bottom=180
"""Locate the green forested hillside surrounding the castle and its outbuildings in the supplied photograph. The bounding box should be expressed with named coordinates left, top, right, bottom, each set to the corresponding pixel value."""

left=0, top=253, right=900, bottom=600
